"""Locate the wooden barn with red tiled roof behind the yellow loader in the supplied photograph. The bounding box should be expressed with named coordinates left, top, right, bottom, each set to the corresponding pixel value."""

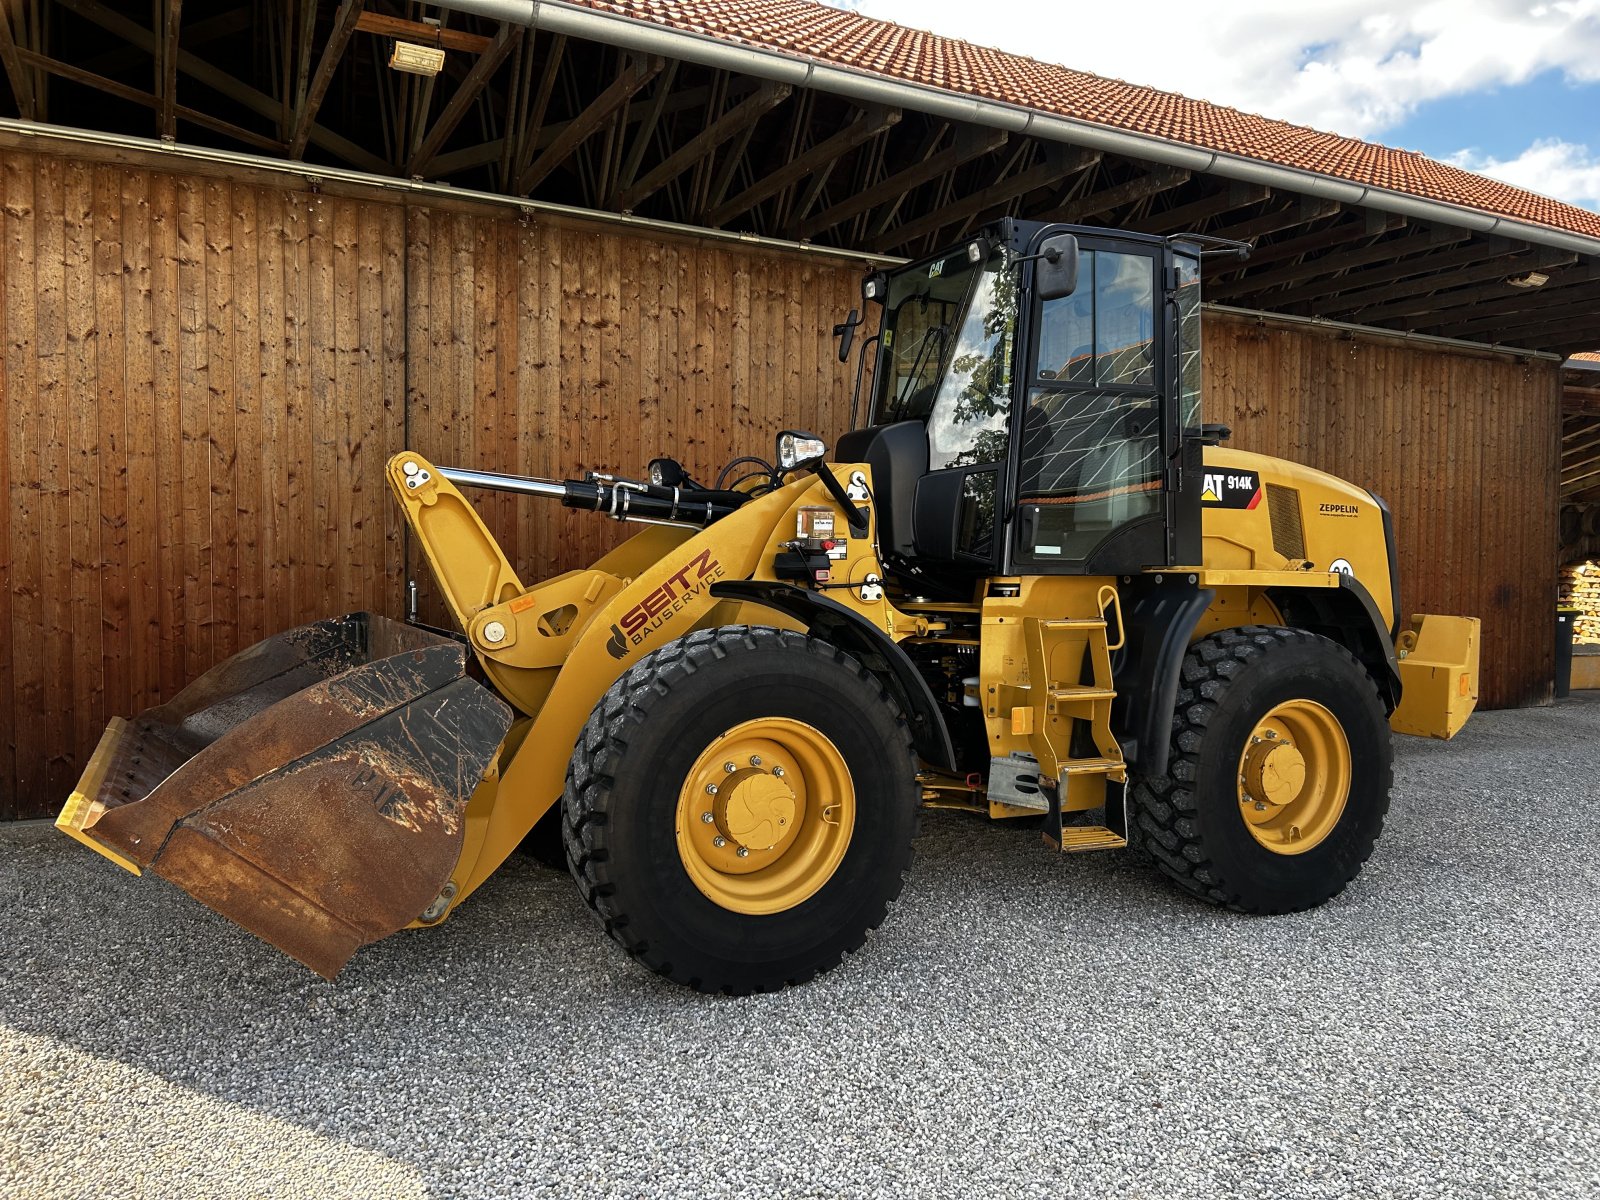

left=0, top=0, right=1600, bottom=818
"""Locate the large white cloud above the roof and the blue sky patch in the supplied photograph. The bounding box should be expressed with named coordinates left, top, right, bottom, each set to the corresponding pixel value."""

left=848, top=0, right=1600, bottom=138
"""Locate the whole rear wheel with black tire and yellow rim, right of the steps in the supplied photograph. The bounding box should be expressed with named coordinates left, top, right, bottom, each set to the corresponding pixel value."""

left=1133, top=626, right=1394, bottom=914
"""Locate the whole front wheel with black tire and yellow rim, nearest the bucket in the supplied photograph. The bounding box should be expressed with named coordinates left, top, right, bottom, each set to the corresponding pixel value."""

left=563, top=626, right=918, bottom=995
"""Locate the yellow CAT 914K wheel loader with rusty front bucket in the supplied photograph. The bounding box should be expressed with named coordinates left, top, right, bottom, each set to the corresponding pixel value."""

left=58, top=221, right=1478, bottom=992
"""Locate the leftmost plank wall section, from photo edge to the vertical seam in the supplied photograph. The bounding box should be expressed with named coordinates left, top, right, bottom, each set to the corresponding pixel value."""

left=0, top=152, right=405, bottom=818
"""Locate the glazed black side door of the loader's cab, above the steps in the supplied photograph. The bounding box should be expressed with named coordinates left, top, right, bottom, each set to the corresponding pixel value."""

left=1010, top=230, right=1176, bottom=574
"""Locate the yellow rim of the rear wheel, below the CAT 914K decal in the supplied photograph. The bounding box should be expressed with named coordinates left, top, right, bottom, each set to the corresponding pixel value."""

left=1238, top=699, right=1350, bottom=854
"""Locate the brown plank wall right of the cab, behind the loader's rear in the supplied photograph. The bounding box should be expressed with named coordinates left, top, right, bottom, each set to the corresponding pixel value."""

left=1203, top=314, right=1560, bottom=720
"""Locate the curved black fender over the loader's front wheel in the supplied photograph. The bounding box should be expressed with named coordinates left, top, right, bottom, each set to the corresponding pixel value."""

left=710, top=579, right=955, bottom=771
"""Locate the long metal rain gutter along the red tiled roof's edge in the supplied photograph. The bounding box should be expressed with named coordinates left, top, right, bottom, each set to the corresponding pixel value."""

left=429, top=0, right=1600, bottom=256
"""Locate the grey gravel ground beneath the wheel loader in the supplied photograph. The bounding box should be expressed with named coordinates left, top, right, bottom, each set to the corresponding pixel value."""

left=0, top=696, right=1600, bottom=1200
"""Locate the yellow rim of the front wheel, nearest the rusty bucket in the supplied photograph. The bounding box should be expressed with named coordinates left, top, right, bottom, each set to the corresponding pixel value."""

left=677, top=717, right=856, bottom=915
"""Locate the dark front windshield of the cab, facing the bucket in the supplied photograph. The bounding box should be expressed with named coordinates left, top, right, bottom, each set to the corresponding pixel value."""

left=872, top=246, right=979, bottom=426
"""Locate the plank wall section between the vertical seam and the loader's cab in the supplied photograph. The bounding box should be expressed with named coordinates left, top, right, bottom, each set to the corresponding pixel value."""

left=406, top=208, right=861, bottom=619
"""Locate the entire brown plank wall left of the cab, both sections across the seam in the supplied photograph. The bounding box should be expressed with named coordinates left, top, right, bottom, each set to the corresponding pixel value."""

left=0, top=143, right=859, bottom=819
